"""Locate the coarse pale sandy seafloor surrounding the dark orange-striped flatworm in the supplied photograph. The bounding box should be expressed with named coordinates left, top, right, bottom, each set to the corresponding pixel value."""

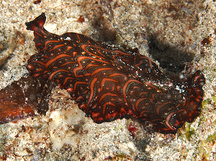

left=0, top=0, right=216, bottom=161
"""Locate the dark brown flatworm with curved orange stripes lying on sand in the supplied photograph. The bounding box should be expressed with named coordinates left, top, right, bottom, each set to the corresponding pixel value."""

left=26, top=13, right=205, bottom=133
